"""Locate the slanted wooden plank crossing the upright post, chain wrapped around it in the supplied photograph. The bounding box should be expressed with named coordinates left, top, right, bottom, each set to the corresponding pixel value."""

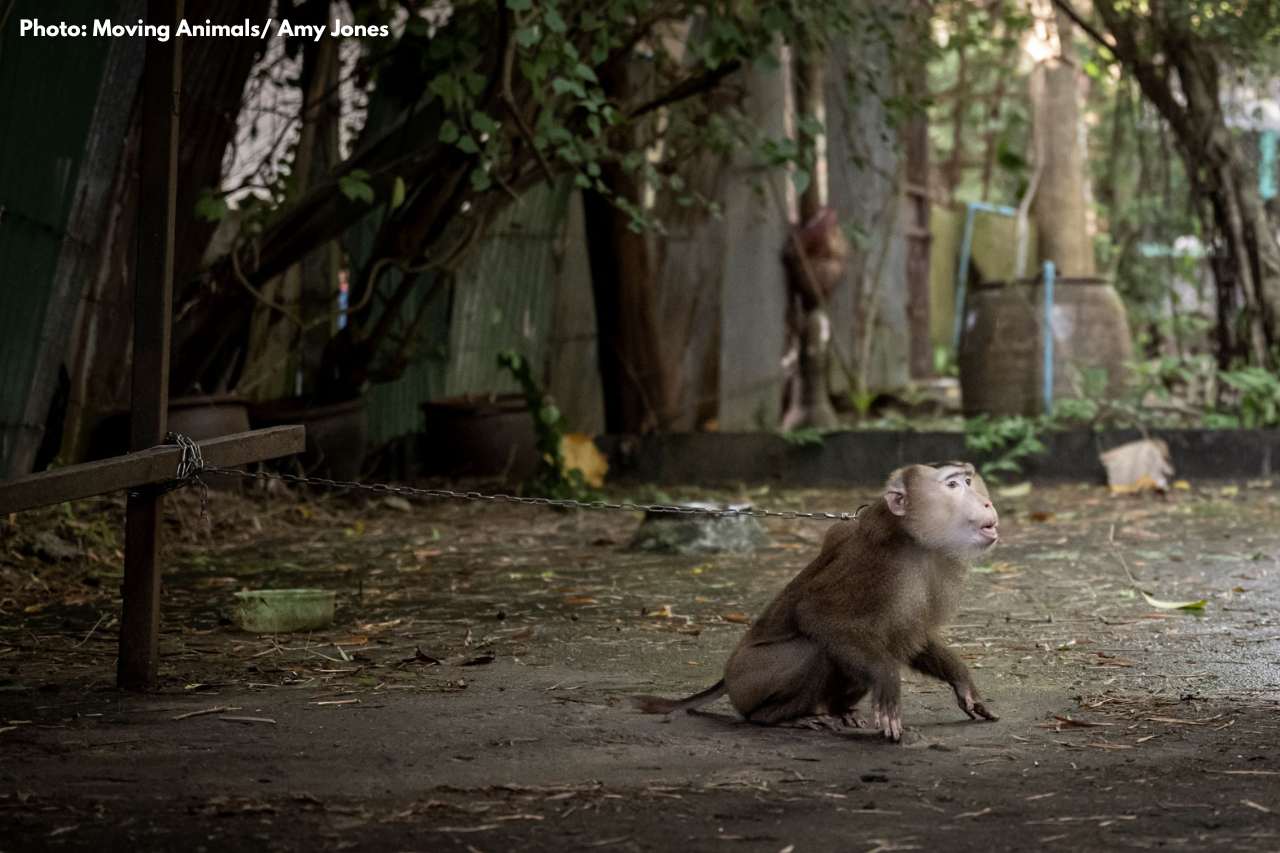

left=0, top=427, right=306, bottom=515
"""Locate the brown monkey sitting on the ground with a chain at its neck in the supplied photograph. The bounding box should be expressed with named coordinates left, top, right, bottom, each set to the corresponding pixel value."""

left=634, top=462, right=998, bottom=742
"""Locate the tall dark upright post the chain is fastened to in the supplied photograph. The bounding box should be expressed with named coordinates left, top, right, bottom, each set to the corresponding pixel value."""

left=116, top=0, right=183, bottom=690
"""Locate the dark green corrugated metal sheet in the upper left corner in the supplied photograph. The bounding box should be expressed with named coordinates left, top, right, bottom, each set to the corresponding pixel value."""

left=0, top=0, right=116, bottom=470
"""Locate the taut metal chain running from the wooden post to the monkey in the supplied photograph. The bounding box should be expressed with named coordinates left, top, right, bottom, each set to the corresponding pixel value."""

left=188, top=448, right=864, bottom=521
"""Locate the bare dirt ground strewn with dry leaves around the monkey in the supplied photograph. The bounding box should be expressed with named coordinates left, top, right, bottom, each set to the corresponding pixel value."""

left=0, top=473, right=1280, bottom=853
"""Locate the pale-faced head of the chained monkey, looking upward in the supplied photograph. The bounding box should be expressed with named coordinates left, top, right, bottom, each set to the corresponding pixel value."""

left=884, top=462, right=1000, bottom=557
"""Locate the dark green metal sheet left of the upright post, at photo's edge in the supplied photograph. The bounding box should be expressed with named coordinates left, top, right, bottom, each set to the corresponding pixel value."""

left=0, top=0, right=132, bottom=476
